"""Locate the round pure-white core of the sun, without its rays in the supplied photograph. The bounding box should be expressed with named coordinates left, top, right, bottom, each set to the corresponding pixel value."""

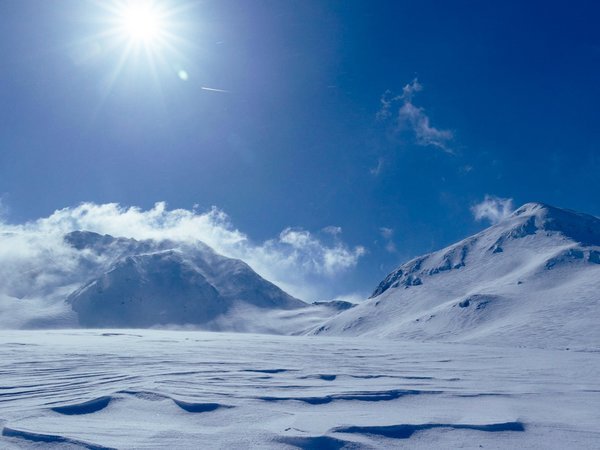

left=118, top=1, right=165, bottom=45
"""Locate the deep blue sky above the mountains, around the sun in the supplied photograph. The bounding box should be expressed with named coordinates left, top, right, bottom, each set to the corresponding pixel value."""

left=0, top=0, right=600, bottom=299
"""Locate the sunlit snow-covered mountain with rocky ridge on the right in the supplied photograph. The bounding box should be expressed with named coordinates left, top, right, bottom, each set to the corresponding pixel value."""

left=313, top=203, right=600, bottom=347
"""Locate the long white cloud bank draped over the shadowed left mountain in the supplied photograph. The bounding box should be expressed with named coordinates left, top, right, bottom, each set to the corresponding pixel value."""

left=0, top=202, right=365, bottom=300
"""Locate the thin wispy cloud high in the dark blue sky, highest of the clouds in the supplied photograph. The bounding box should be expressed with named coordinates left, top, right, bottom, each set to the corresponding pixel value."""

left=377, top=78, right=454, bottom=153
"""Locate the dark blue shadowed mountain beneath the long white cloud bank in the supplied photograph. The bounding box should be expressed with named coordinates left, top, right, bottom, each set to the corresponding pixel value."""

left=65, top=231, right=307, bottom=328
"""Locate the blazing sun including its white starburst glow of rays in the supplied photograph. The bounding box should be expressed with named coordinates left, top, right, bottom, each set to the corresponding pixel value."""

left=81, top=0, right=197, bottom=98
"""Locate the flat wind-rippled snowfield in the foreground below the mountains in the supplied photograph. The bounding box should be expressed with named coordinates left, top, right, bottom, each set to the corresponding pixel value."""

left=0, top=330, right=600, bottom=449
